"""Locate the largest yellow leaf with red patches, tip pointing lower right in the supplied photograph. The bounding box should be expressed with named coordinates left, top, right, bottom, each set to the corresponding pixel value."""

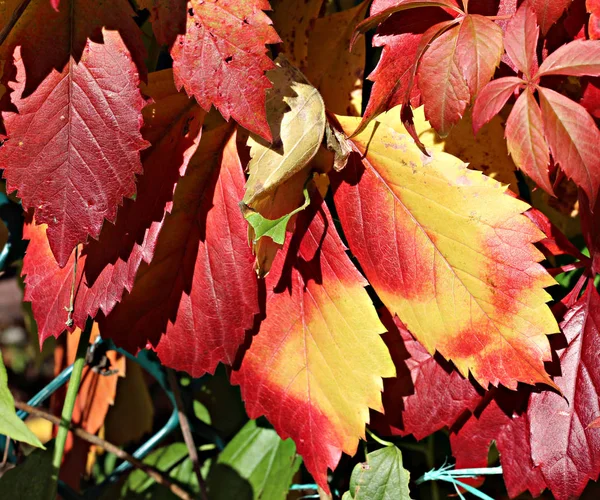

left=334, top=117, right=558, bottom=388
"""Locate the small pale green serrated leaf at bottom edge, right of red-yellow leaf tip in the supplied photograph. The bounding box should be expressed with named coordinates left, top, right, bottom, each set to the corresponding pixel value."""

left=343, top=446, right=410, bottom=500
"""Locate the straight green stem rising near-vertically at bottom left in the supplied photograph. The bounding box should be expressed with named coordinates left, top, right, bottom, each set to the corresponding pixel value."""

left=49, top=319, right=94, bottom=500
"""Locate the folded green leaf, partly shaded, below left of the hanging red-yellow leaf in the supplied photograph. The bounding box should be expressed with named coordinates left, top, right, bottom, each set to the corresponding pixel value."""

left=208, top=420, right=302, bottom=500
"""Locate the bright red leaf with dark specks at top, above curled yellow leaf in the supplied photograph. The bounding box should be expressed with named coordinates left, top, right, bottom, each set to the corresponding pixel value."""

left=171, top=0, right=280, bottom=141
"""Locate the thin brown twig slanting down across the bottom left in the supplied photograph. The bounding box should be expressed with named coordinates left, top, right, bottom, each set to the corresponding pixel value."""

left=15, top=401, right=193, bottom=500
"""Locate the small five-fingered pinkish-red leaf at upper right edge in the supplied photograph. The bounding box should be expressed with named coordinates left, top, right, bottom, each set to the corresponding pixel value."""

left=473, top=3, right=600, bottom=204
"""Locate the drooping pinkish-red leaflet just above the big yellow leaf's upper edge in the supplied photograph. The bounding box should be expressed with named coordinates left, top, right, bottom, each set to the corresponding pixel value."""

left=418, top=27, right=471, bottom=137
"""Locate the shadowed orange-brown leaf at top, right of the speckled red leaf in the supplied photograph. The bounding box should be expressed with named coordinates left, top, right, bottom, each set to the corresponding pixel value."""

left=305, top=1, right=369, bottom=116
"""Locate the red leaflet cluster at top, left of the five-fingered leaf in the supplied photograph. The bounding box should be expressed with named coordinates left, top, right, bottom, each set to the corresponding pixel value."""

left=355, top=0, right=503, bottom=137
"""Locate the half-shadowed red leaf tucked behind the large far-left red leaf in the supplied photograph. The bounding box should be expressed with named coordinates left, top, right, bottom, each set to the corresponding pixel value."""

left=22, top=71, right=204, bottom=345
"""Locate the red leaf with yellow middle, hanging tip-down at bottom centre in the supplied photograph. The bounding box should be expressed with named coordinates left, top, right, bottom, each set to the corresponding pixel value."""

left=231, top=190, right=394, bottom=491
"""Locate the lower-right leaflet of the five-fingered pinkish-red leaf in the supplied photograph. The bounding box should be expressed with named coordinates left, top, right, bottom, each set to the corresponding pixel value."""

left=538, top=87, right=600, bottom=204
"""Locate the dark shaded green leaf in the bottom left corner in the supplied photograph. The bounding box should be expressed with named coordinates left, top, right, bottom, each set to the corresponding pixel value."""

left=0, top=442, right=54, bottom=500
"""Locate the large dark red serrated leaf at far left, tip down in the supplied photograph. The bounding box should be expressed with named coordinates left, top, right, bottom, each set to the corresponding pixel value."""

left=0, top=31, right=146, bottom=267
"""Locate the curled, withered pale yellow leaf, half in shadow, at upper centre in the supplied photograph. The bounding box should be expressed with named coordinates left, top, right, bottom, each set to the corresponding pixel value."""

left=243, top=56, right=325, bottom=208
